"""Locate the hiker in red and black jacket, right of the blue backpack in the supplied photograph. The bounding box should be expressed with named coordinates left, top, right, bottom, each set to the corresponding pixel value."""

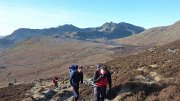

left=93, top=65, right=112, bottom=101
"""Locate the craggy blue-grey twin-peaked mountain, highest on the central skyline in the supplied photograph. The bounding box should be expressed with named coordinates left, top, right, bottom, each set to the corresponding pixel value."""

left=75, top=22, right=145, bottom=40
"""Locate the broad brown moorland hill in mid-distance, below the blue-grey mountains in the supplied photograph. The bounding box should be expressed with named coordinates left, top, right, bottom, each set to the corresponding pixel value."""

left=0, top=36, right=144, bottom=86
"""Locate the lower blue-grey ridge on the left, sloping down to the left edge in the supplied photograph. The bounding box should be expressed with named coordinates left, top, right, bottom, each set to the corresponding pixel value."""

left=0, top=24, right=79, bottom=47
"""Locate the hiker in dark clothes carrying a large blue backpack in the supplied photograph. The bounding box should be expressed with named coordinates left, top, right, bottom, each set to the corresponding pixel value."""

left=69, top=65, right=83, bottom=101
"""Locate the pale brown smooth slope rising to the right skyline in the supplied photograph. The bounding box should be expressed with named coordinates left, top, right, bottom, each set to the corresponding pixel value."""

left=116, top=21, right=180, bottom=45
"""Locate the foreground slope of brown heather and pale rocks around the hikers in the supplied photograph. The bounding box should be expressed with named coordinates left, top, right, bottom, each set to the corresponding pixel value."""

left=0, top=40, right=180, bottom=101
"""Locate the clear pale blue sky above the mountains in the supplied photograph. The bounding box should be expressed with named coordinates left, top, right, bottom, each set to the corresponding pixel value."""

left=0, top=0, right=180, bottom=36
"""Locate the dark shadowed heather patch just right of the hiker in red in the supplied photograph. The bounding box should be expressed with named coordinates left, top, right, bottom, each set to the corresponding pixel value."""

left=107, top=82, right=168, bottom=100
